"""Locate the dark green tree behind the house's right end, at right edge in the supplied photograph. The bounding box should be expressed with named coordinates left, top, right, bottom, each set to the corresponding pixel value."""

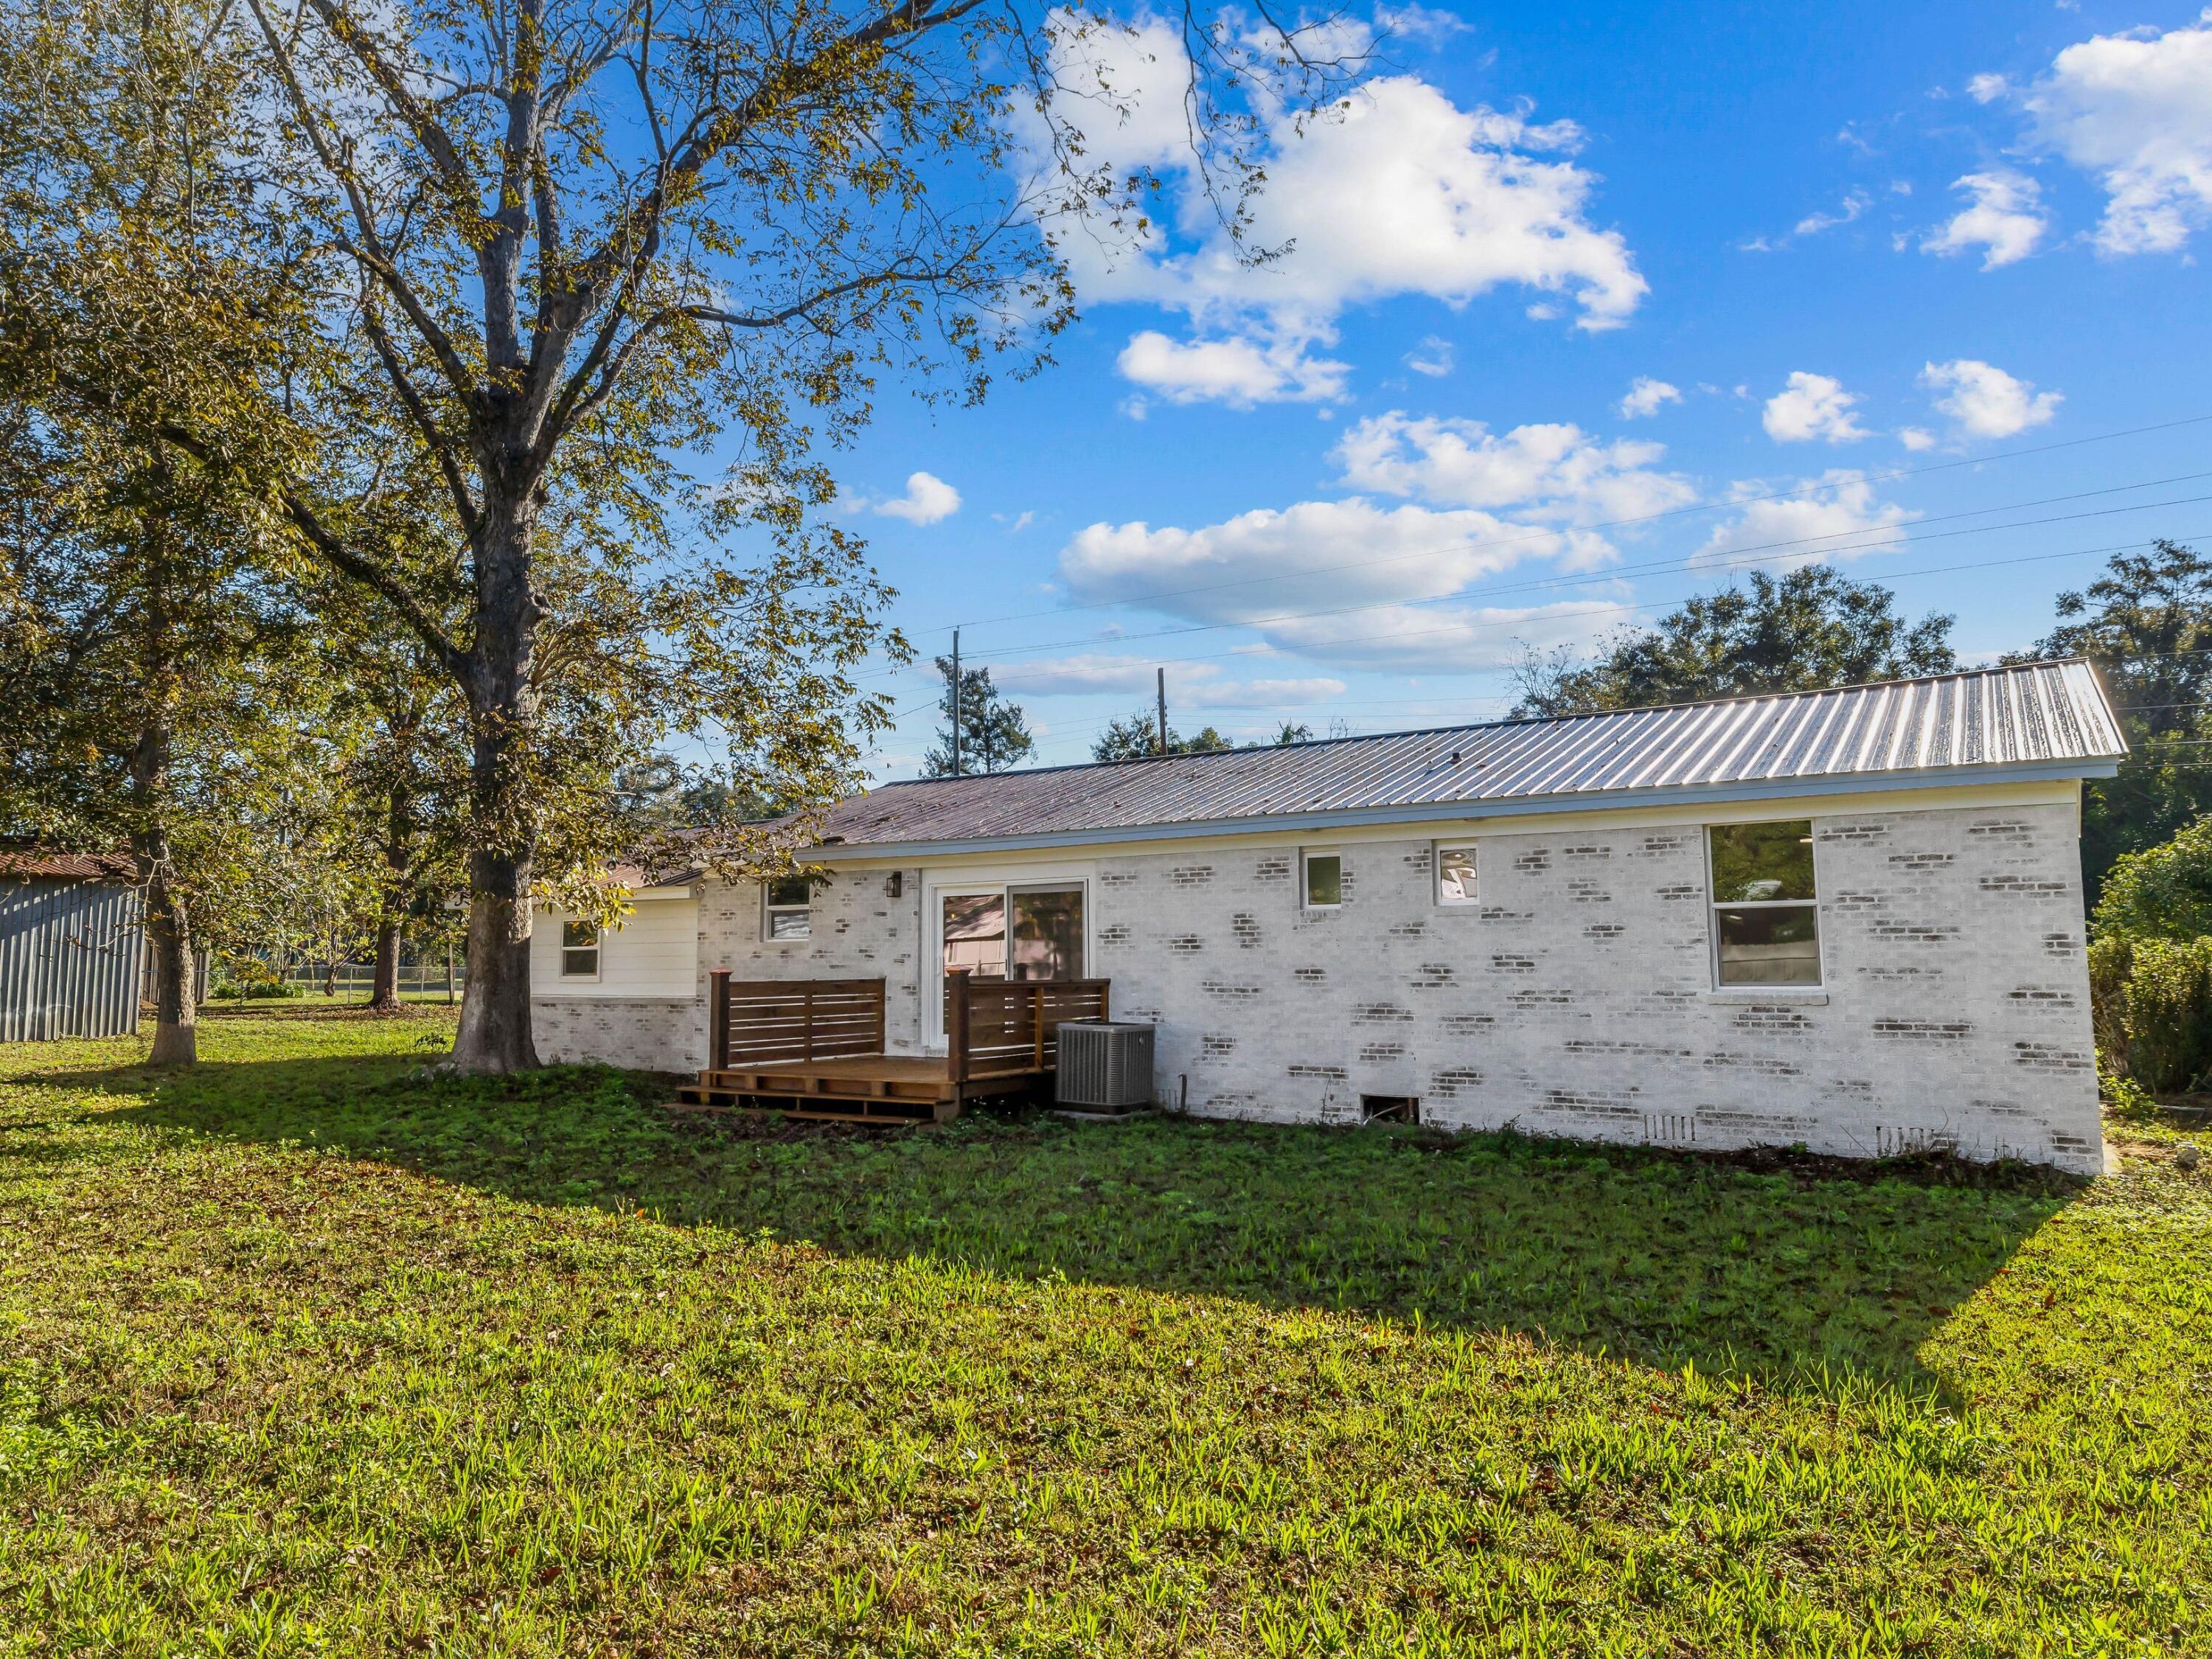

left=2015, top=538, right=2212, bottom=898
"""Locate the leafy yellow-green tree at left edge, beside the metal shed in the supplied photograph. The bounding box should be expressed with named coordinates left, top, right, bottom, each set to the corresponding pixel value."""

left=0, top=0, right=319, bottom=1062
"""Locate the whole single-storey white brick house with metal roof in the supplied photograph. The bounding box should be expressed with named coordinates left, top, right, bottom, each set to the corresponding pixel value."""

left=533, top=664, right=2124, bottom=1170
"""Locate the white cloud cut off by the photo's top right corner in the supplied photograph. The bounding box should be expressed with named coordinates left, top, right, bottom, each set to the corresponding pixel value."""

left=2026, top=9, right=2212, bottom=254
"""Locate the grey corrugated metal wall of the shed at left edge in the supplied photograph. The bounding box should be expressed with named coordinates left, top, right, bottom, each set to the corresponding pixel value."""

left=0, top=880, right=146, bottom=1042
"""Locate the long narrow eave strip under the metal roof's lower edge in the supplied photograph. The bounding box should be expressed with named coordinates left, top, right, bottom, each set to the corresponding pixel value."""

left=805, top=759, right=2119, bottom=865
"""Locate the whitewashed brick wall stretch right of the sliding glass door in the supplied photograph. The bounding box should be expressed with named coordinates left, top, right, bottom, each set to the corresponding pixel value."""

left=1097, top=805, right=2101, bottom=1170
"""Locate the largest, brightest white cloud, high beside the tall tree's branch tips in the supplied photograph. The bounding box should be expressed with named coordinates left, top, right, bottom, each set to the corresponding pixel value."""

left=1055, top=22, right=1648, bottom=403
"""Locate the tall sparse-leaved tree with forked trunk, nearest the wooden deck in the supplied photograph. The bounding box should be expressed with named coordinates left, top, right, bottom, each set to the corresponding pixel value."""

left=199, top=0, right=1343, bottom=1073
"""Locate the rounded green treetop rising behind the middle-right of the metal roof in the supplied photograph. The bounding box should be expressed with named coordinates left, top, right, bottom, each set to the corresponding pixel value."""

left=1513, top=564, right=1958, bottom=717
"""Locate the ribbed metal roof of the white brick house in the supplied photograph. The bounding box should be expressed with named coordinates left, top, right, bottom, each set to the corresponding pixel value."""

left=818, top=659, right=2128, bottom=856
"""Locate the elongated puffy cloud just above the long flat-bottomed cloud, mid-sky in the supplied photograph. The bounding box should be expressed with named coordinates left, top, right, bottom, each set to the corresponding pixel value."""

left=1334, top=409, right=1697, bottom=533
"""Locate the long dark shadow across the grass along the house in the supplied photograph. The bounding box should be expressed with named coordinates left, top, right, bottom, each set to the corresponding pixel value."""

left=26, top=1057, right=2079, bottom=1387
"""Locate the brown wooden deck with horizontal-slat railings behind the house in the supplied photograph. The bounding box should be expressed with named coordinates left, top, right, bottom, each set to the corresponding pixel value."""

left=672, top=971, right=1108, bottom=1124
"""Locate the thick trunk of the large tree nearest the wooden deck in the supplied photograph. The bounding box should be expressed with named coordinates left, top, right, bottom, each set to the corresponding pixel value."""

left=453, top=480, right=540, bottom=1075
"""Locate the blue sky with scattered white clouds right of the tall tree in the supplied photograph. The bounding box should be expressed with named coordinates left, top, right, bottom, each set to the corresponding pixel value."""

left=805, top=0, right=2212, bottom=776
